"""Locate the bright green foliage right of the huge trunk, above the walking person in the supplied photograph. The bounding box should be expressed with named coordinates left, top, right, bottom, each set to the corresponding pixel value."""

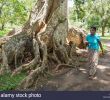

left=69, top=0, right=110, bottom=32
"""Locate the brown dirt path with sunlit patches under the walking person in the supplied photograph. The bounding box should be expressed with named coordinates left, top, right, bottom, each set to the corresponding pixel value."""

left=41, top=40, right=110, bottom=91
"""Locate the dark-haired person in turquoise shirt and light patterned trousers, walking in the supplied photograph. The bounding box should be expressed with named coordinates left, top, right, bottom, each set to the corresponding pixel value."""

left=86, top=27, right=103, bottom=79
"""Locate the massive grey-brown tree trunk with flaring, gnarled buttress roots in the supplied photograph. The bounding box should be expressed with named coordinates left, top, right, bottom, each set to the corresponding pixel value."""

left=1, top=0, right=77, bottom=89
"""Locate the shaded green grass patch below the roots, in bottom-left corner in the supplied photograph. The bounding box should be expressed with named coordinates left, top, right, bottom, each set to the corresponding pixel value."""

left=0, top=73, right=26, bottom=91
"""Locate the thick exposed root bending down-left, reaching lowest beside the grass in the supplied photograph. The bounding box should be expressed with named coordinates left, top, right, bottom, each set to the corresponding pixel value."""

left=20, top=44, right=48, bottom=89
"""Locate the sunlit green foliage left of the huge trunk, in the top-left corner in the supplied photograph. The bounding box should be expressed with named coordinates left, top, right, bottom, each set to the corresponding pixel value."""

left=0, top=0, right=35, bottom=30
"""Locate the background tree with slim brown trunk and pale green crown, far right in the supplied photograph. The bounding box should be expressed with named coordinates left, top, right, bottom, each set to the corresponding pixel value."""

left=94, top=0, right=110, bottom=36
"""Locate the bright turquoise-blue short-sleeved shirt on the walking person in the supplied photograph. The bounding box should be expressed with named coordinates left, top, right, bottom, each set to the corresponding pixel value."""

left=86, top=34, right=100, bottom=51
